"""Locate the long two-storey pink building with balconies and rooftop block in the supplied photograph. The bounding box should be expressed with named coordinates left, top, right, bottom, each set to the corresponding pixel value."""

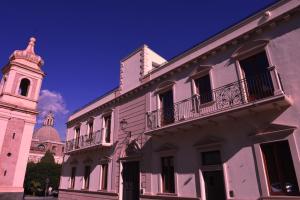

left=59, top=0, right=300, bottom=200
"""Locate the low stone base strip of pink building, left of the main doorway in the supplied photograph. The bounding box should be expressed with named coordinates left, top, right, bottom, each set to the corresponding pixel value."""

left=58, top=189, right=119, bottom=200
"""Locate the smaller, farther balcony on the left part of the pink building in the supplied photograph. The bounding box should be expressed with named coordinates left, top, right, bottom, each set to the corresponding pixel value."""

left=66, top=129, right=112, bottom=154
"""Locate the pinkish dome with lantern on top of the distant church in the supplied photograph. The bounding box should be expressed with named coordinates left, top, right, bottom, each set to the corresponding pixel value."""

left=33, top=112, right=61, bottom=142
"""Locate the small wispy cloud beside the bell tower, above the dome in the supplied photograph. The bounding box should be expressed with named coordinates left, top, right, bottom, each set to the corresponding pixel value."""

left=38, top=90, right=69, bottom=122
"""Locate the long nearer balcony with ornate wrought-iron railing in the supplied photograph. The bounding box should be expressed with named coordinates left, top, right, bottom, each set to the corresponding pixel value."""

left=146, top=67, right=291, bottom=135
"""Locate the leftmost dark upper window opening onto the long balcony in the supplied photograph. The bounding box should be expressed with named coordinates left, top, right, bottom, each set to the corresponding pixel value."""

left=159, top=90, right=175, bottom=126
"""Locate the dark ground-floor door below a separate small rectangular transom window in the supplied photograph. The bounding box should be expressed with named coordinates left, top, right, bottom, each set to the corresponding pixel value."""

left=203, top=170, right=226, bottom=200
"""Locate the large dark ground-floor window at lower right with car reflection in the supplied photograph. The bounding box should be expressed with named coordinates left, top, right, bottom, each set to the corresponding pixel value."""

left=261, top=141, right=300, bottom=195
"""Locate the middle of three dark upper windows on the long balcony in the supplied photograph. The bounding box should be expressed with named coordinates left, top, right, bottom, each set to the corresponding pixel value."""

left=195, top=74, right=213, bottom=104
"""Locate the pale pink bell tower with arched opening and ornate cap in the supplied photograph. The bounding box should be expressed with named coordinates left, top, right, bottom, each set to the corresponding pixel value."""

left=0, top=38, right=45, bottom=200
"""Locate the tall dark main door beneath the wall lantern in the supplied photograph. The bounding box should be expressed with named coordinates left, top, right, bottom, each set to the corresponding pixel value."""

left=122, top=162, right=140, bottom=200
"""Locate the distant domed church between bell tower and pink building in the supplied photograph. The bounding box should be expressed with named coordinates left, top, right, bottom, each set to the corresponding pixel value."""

left=28, top=112, right=64, bottom=164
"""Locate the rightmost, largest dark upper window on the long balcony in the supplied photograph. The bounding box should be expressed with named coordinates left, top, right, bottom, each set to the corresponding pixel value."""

left=239, top=51, right=274, bottom=101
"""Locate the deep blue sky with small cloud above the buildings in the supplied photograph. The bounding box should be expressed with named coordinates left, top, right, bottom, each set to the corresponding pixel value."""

left=0, top=0, right=275, bottom=139
